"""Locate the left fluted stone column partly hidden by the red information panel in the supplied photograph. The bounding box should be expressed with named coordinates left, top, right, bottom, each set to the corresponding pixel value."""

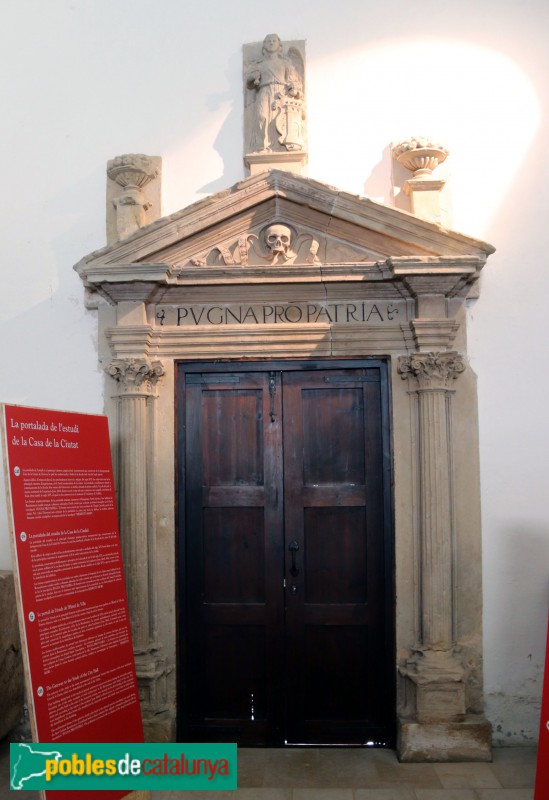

left=107, top=358, right=165, bottom=721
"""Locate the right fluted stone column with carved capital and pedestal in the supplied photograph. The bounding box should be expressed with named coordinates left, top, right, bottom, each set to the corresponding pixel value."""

left=398, top=352, right=465, bottom=722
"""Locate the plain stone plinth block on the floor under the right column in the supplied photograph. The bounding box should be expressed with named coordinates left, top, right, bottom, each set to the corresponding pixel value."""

left=397, top=716, right=492, bottom=762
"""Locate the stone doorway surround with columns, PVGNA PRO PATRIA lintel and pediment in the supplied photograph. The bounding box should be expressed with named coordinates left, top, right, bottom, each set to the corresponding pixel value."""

left=77, top=170, right=493, bottom=761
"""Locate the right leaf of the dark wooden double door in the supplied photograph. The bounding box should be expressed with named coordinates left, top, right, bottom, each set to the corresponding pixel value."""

left=283, top=369, right=388, bottom=744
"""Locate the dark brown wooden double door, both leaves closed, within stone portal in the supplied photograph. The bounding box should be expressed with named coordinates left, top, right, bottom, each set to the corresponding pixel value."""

left=178, top=361, right=395, bottom=746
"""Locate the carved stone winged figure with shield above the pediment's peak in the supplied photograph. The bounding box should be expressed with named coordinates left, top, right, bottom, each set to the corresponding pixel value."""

left=244, top=33, right=305, bottom=153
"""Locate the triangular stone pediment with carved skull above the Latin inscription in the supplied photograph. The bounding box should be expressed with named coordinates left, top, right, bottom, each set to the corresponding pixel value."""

left=75, top=170, right=494, bottom=299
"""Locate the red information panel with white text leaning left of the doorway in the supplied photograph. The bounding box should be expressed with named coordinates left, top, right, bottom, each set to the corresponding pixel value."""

left=1, top=405, right=143, bottom=800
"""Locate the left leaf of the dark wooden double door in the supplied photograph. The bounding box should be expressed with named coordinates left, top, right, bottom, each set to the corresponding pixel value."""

left=185, top=373, right=283, bottom=744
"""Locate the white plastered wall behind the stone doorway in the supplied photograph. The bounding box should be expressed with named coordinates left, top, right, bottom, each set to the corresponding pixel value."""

left=0, top=0, right=549, bottom=743
